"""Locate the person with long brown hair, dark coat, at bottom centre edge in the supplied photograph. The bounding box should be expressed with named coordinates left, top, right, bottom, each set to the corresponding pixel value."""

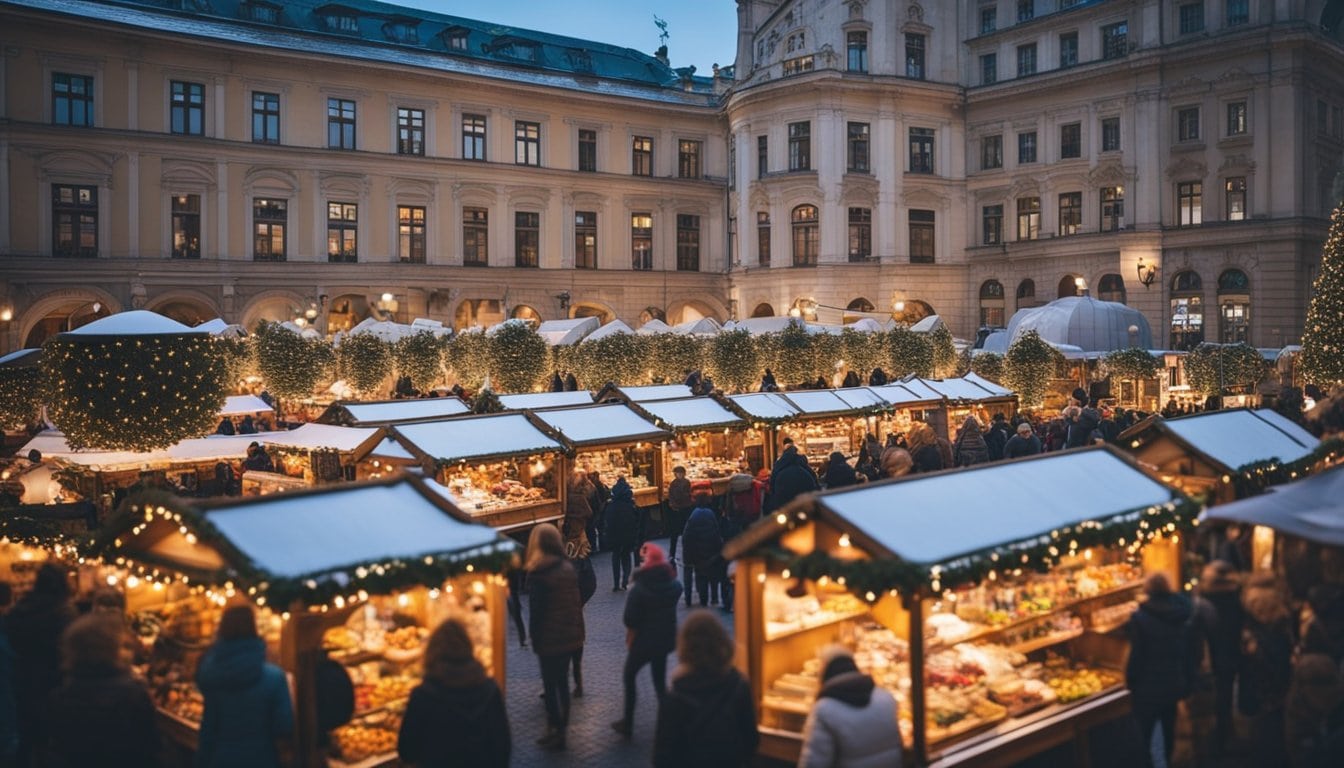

left=653, top=611, right=761, bottom=768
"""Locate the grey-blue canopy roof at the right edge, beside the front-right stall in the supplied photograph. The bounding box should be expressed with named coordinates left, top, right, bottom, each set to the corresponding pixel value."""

left=1199, top=464, right=1344, bottom=546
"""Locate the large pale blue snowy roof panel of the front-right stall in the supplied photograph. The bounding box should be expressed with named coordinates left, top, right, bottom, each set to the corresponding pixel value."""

left=817, top=448, right=1175, bottom=565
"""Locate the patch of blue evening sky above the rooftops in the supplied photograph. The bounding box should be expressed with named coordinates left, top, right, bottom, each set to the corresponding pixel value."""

left=388, top=0, right=738, bottom=77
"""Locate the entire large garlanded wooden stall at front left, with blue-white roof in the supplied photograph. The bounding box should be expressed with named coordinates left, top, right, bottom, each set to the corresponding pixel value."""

left=95, top=476, right=516, bottom=768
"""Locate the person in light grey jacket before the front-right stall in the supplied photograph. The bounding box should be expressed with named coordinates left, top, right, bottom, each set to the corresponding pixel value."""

left=798, top=646, right=902, bottom=768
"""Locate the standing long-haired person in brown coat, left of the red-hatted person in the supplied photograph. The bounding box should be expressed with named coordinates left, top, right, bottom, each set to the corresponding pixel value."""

left=527, top=523, right=583, bottom=749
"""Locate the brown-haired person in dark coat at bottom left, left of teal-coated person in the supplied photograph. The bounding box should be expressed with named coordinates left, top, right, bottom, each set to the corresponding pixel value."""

left=43, top=613, right=159, bottom=768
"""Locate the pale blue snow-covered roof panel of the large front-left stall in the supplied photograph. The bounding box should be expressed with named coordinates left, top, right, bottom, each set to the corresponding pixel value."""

left=206, top=479, right=500, bottom=578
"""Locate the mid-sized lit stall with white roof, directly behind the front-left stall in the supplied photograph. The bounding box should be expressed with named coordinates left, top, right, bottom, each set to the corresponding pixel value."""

left=391, top=413, right=564, bottom=530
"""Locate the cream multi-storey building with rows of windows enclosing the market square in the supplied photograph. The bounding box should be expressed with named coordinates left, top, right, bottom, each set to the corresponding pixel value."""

left=0, top=0, right=1344, bottom=350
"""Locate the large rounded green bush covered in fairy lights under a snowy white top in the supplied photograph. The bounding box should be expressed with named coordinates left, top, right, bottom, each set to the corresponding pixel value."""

left=42, top=334, right=227, bottom=451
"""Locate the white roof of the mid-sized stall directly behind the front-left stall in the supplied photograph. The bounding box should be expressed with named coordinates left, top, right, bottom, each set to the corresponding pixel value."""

left=390, top=413, right=564, bottom=464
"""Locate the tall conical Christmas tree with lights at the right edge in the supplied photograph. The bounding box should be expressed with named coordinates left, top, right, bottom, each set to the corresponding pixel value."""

left=1300, top=203, right=1344, bottom=387
